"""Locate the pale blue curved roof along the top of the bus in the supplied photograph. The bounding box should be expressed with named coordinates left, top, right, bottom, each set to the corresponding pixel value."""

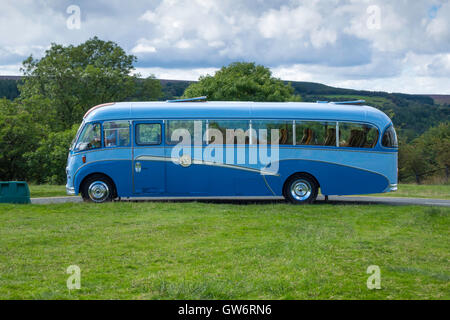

left=84, top=101, right=391, bottom=129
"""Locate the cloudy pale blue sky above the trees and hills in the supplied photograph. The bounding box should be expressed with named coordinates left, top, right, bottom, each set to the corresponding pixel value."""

left=0, top=0, right=450, bottom=94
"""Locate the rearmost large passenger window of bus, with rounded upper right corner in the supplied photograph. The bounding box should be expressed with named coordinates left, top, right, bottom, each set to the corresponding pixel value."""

left=339, top=122, right=378, bottom=148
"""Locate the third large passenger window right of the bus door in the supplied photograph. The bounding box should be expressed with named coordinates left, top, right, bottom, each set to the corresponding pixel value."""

left=252, top=120, right=294, bottom=145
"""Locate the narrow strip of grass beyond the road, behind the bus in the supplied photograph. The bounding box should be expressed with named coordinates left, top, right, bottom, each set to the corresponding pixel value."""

left=30, top=184, right=450, bottom=200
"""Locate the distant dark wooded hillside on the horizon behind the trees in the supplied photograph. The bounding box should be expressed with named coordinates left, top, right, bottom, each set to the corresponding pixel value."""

left=0, top=76, right=450, bottom=140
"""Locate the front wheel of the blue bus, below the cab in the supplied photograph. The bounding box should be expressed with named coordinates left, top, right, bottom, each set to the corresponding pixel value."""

left=81, top=174, right=115, bottom=203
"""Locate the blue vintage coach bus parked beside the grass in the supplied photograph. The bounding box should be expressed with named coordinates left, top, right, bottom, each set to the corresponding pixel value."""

left=66, top=100, right=398, bottom=204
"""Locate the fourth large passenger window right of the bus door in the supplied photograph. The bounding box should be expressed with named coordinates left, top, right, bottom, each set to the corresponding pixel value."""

left=295, top=121, right=336, bottom=146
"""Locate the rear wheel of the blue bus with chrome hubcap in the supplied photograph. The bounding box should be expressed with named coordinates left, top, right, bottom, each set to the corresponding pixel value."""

left=283, top=173, right=319, bottom=204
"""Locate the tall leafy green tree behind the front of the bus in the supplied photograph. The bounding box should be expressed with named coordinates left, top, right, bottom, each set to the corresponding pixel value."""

left=19, top=37, right=137, bottom=130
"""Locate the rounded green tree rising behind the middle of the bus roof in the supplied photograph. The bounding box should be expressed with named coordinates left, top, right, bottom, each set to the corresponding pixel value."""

left=183, top=62, right=301, bottom=101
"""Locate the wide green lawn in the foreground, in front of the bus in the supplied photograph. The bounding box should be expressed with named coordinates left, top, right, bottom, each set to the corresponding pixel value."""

left=0, top=202, right=450, bottom=299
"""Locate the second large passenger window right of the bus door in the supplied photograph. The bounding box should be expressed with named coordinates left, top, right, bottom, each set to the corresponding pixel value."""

left=207, top=120, right=250, bottom=144
